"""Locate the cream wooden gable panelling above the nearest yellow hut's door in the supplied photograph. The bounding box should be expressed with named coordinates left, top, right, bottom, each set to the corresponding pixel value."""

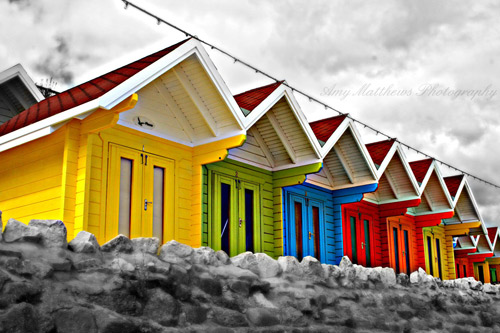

left=120, top=55, right=240, bottom=143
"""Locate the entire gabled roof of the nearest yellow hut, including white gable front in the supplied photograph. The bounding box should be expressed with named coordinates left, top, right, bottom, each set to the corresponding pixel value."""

left=0, top=38, right=249, bottom=151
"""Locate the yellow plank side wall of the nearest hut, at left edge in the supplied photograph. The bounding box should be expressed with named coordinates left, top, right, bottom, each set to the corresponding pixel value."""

left=0, top=128, right=65, bottom=227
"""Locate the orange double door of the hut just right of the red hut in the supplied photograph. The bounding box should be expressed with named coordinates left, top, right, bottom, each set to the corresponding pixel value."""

left=388, top=218, right=413, bottom=275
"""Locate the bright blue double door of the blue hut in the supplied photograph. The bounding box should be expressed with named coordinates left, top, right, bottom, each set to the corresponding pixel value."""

left=286, top=193, right=326, bottom=262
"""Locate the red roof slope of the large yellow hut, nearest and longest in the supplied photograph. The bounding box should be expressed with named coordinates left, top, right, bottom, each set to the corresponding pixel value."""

left=0, top=39, right=188, bottom=136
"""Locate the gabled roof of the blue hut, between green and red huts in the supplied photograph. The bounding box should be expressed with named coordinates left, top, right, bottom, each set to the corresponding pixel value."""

left=306, top=115, right=377, bottom=190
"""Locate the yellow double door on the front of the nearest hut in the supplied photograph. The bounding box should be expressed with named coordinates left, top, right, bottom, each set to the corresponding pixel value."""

left=106, top=144, right=175, bottom=243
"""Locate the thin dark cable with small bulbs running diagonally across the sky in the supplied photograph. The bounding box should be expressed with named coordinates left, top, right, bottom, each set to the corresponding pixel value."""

left=122, top=0, right=500, bottom=189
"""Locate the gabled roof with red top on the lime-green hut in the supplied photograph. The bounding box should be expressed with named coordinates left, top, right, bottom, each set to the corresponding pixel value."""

left=228, top=82, right=322, bottom=171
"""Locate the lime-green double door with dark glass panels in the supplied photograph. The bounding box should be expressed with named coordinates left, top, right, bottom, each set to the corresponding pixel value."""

left=210, top=172, right=260, bottom=256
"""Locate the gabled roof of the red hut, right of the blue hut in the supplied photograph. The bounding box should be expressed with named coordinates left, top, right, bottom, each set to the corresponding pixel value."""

left=364, top=139, right=420, bottom=204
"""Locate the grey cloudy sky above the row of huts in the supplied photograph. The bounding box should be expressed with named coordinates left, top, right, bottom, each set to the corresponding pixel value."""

left=0, top=0, right=500, bottom=225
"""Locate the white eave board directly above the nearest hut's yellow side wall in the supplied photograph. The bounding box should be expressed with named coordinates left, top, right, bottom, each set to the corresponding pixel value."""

left=0, top=99, right=99, bottom=151
